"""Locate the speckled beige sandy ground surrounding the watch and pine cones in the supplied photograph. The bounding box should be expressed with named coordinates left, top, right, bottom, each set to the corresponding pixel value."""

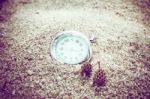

left=0, top=0, right=150, bottom=99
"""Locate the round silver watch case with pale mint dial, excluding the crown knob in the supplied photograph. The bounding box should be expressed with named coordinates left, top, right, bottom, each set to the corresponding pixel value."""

left=51, top=31, right=91, bottom=64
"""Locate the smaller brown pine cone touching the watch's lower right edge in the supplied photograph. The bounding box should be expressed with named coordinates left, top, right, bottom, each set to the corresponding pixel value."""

left=80, top=62, right=92, bottom=78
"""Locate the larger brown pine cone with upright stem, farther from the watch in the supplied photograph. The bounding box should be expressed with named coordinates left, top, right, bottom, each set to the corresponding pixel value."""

left=93, top=69, right=106, bottom=87
